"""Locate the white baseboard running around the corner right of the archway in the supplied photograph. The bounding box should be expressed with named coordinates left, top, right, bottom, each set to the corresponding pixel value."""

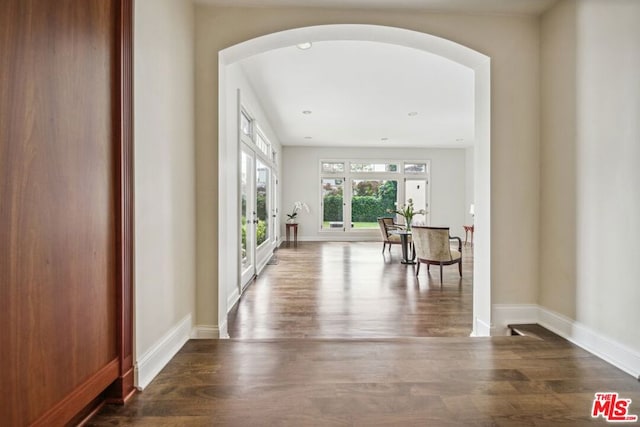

left=492, top=304, right=640, bottom=380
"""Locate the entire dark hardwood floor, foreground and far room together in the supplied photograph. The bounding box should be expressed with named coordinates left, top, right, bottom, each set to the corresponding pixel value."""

left=89, top=243, right=640, bottom=427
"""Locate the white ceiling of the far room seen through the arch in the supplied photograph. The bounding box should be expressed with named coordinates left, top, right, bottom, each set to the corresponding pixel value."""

left=240, top=41, right=474, bottom=147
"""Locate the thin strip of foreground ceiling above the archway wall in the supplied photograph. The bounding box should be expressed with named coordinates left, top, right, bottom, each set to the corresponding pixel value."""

left=196, top=0, right=557, bottom=15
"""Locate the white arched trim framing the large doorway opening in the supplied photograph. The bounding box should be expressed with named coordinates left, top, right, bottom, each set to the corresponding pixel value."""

left=218, top=24, right=491, bottom=338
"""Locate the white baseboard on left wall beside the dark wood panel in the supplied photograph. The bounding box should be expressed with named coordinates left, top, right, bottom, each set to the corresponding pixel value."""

left=134, top=314, right=191, bottom=390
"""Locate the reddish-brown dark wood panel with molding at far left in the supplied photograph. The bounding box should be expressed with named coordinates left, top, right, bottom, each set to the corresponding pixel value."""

left=0, top=0, right=133, bottom=426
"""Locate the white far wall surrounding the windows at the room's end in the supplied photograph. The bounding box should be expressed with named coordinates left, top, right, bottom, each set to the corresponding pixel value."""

left=281, top=146, right=465, bottom=240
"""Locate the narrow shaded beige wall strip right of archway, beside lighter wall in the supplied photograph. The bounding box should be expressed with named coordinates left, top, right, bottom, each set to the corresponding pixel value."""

left=539, top=1, right=577, bottom=319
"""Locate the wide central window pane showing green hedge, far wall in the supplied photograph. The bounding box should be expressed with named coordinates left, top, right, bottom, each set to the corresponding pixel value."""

left=351, top=179, right=398, bottom=230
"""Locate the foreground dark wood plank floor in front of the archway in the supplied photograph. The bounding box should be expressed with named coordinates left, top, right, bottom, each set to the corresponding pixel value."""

left=89, top=337, right=640, bottom=427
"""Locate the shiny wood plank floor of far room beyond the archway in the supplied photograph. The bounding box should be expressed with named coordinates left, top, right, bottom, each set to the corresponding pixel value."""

left=229, top=242, right=473, bottom=339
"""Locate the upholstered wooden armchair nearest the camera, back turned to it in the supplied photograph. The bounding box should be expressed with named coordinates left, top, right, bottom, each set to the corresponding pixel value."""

left=411, top=225, right=462, bottom=285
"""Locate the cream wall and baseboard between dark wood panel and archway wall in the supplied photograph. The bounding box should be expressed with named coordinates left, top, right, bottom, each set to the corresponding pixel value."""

left=133, top=0, right=196, bottom=387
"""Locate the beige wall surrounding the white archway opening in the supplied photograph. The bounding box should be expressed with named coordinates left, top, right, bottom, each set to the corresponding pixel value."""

left=196, top=4, right=540, bottom=332
